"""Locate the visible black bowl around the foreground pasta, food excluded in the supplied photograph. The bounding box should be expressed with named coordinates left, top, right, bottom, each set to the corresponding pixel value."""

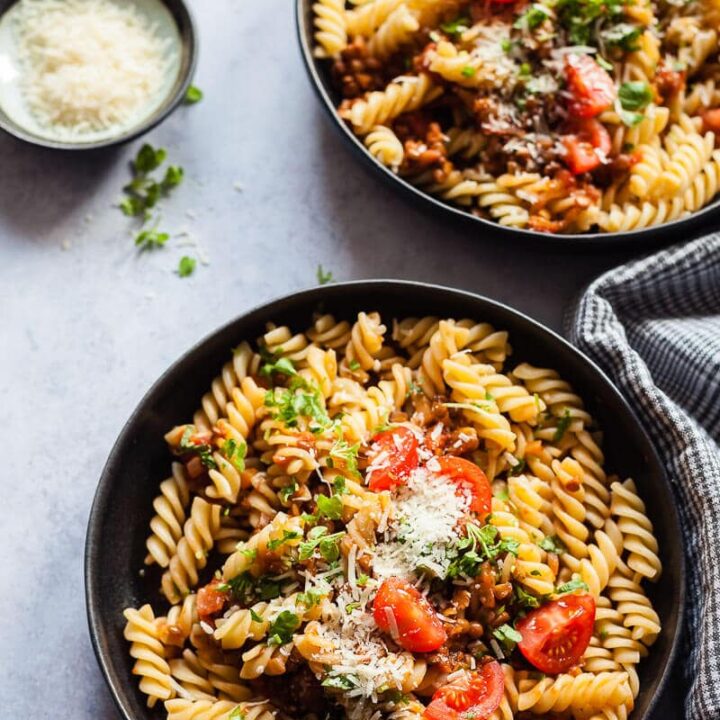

left=85, top=280, right=685, bottom=720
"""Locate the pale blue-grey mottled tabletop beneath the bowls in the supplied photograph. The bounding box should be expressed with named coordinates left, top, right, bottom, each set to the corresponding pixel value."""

left=0, top=0, right=679, bottom=720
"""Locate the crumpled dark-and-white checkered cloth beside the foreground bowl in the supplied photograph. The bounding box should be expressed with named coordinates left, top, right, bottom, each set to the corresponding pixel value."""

left=567, top=234, right=720, bottom=720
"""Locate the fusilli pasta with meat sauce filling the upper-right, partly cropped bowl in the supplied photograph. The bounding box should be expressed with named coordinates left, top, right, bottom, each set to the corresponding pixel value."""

left=299, top=0, right=720, bottom=237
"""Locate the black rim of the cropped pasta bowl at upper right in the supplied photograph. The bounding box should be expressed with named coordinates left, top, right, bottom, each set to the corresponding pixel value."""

left=295, top=0, right=720, bottom=249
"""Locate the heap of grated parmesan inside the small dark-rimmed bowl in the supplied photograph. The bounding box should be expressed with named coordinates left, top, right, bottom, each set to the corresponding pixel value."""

left=14, top=0, right=173, bottom=137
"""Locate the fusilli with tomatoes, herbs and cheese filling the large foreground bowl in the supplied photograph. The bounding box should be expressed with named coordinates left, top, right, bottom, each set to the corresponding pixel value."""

left=88, top=282, right=678, bottom=720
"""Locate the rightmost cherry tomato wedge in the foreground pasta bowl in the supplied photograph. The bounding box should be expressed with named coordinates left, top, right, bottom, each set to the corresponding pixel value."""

left=515, top=593, right=595, bottom=675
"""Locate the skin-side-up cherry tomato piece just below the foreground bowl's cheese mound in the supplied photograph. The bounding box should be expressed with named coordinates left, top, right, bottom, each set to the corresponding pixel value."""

left=373, top=578, right=447, bottom=652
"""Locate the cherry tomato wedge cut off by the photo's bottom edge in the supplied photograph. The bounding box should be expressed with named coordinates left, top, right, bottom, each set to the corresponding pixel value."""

left=423, top=660, right=505, bottom=720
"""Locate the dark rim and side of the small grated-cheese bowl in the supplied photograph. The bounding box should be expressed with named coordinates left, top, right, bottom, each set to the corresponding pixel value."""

left=0, top=0, right=199, bottom=151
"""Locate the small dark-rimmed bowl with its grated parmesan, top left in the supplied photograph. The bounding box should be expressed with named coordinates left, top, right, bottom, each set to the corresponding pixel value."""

left=0, top=0, right=197, bottom=150
